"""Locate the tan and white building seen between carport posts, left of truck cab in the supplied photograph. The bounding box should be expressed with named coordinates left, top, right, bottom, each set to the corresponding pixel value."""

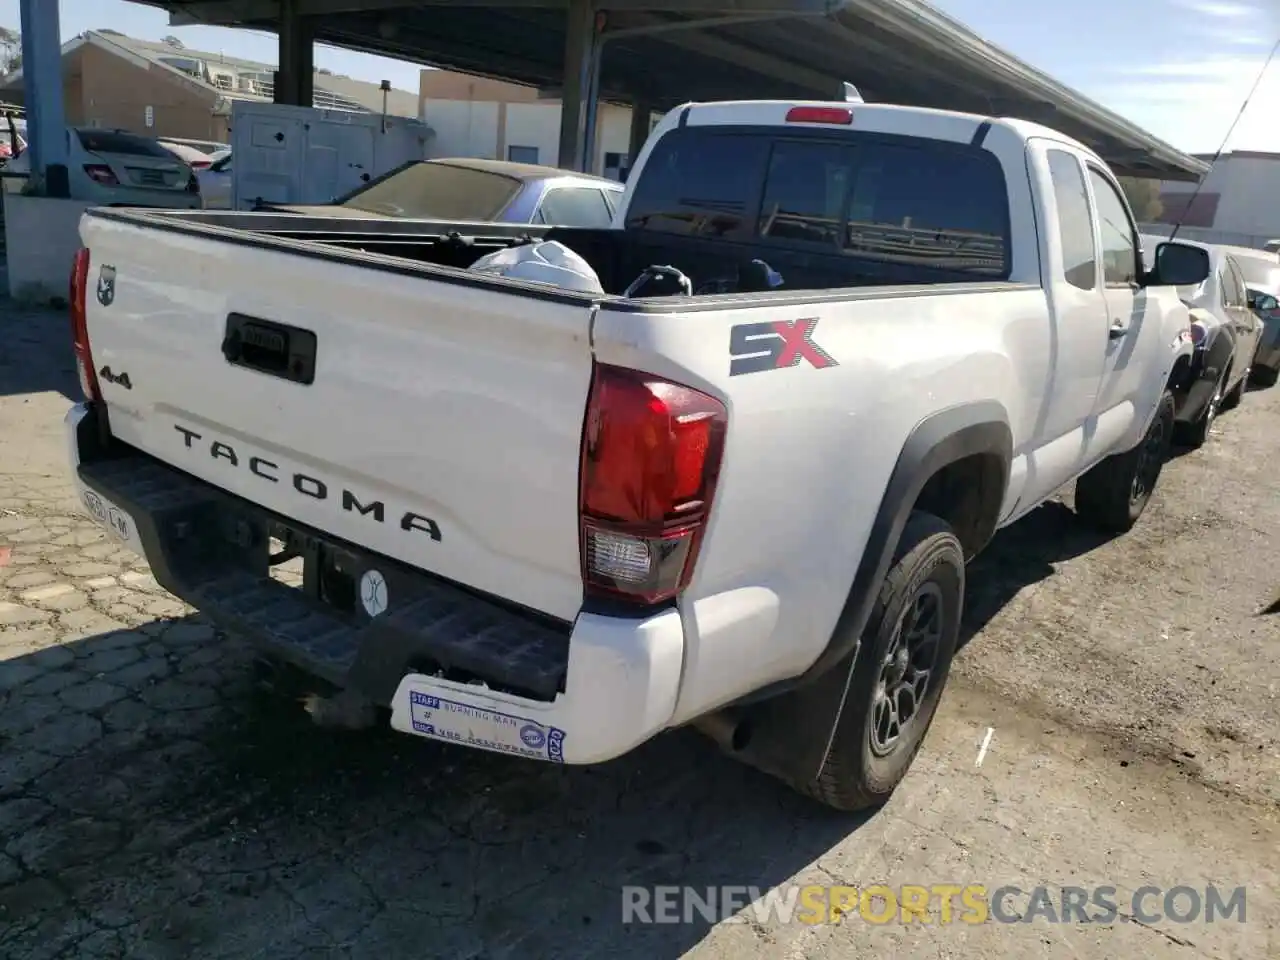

left=419, top=70, right=650, bottom=179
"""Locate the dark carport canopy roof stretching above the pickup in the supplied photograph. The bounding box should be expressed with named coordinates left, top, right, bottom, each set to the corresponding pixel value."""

left=133, top=0, right=1208, bottom=180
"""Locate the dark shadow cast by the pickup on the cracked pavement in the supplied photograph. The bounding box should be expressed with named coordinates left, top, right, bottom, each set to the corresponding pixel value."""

left=0, top=503, right=1121, bottom=960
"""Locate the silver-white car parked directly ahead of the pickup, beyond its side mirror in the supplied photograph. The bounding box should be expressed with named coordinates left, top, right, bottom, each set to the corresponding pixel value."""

left=1143, top=237, right=1262, bottom=447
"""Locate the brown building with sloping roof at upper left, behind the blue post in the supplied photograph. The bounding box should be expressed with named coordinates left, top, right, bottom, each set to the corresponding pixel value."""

left=0, top=29, right=417, bottom=142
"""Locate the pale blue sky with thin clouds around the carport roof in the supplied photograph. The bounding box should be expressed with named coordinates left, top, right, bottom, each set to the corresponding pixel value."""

left=0, top=0, right=1280, bottom=152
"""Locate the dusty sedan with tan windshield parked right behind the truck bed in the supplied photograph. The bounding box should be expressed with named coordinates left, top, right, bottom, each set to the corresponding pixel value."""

left=260, top=157, right=623, bottom=228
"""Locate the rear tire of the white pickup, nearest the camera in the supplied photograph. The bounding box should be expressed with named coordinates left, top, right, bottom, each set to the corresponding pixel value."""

left=794, top=511, right=964, bottom=812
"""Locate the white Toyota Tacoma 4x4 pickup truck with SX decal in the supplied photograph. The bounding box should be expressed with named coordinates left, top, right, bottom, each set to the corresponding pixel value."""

left=67, top=101, right=1207, bottom=809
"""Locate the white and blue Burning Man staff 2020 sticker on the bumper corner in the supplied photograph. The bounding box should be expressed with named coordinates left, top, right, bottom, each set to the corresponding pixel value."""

left=408, top=690, right=564, bottom=763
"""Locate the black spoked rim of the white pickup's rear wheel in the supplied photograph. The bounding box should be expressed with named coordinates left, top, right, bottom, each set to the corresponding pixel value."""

left=870, top=581, right=945, bottom=756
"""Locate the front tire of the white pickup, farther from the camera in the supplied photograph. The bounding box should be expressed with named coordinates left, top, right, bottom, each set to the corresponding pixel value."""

left=1075, top=390, right=1174, bottom=534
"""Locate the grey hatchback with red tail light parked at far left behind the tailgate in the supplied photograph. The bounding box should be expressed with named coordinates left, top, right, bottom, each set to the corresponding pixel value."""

left=5, top=127, right=200, bottom=209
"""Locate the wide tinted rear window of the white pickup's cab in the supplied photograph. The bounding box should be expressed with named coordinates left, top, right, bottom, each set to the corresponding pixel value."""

left=626, top=127, right=1010, bottom=278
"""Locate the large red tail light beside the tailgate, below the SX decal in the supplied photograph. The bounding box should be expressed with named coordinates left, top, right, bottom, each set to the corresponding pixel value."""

left=579, top=365, right=728, bottom=604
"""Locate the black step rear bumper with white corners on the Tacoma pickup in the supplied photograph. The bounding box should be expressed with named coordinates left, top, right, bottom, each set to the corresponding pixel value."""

left=65, top=403, right=685, bottom=763
